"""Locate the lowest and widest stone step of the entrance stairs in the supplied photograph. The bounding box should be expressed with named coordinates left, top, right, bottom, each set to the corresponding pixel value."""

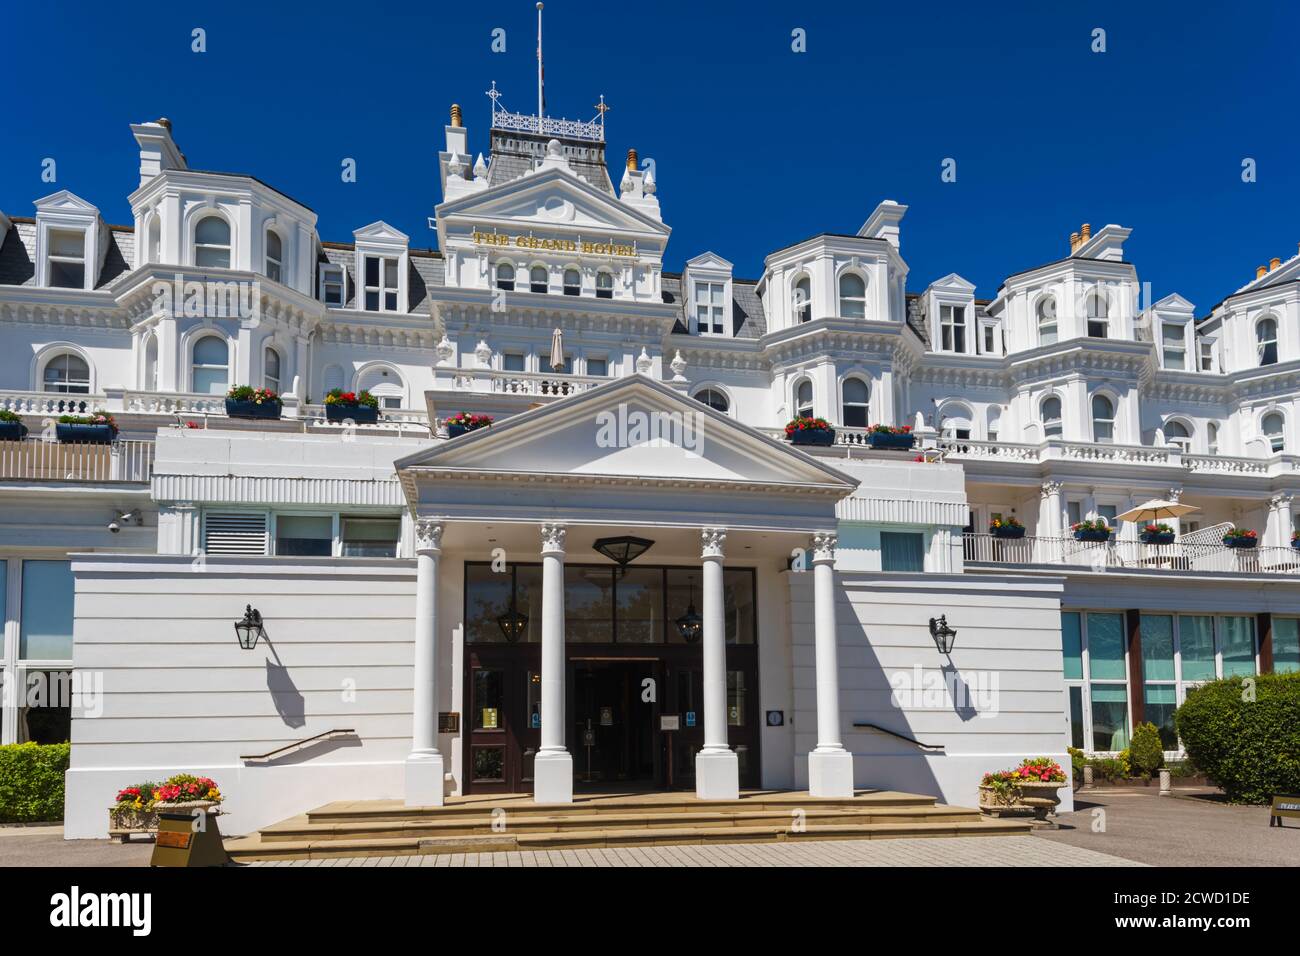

left=226, top=819, right=1031, bottom=862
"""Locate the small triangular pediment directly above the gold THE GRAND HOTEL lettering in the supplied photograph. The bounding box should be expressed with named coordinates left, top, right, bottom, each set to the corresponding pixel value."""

left=437, top=168, right=671, bottom=238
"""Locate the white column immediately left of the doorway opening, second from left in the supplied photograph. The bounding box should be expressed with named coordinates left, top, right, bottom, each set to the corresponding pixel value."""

left=533, top=524, right=573, bottom=804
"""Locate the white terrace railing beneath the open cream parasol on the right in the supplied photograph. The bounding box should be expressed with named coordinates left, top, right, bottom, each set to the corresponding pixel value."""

left=962, top=533, right=1300, bottom=575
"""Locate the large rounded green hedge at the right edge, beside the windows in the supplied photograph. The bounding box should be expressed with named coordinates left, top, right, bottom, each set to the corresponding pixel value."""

left=1174, top=672, right=1300, bottom=804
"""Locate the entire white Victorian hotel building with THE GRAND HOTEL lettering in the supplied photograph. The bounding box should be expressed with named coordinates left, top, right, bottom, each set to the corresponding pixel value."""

left=0, top=100, right=1300, bottom=836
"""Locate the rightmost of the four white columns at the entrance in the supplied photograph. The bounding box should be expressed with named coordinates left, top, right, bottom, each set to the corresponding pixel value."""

left=809, top=533, right=853, bottom=797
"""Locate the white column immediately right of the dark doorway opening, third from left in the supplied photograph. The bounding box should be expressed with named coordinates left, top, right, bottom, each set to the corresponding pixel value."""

left=696, top=528, right=740, bottom=800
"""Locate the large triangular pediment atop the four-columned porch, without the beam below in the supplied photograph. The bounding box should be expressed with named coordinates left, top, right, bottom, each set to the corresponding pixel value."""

left=397, top=375, right=858, bottom=494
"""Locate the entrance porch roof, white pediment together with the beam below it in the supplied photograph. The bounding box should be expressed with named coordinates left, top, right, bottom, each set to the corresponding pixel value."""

left=395, top=375, right=858, bottom=533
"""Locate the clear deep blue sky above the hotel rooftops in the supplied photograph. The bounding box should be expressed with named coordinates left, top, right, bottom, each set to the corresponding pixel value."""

left=0, top=0, right=1300, bottom=313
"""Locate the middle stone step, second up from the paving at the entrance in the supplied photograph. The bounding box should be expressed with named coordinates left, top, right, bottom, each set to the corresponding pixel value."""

left=261, top=806, right=980, bottom=843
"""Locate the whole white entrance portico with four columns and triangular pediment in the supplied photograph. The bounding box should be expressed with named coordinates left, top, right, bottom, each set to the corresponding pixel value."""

left=397, top=376, right=857, bottom=805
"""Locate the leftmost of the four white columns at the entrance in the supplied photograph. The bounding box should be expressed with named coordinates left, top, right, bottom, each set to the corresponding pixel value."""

left=406, top=518, right=443, bottom=806
